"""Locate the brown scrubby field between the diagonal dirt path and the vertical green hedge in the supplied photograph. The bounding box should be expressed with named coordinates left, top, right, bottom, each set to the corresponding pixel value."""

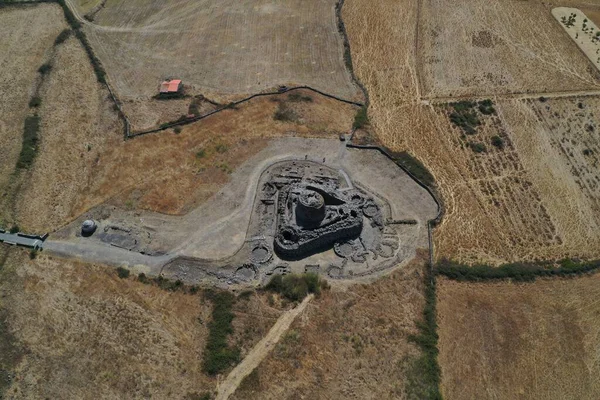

left=233, top=252, right=426, bottom=399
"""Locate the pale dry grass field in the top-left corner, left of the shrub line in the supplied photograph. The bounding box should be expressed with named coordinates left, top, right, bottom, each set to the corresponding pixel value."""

left=0, top=4, right=66, bottom=224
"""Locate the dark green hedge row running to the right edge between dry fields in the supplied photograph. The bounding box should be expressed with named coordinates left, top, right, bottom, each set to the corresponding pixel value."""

left=435, top=259, right=600, bottom=281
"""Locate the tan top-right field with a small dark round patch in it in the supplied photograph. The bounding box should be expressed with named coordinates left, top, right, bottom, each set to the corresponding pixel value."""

left=418, top=0, right=600, bottom=98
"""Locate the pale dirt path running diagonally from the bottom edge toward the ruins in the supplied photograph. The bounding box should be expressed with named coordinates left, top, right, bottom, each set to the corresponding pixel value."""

left=216, top=294, right=313, bottom=400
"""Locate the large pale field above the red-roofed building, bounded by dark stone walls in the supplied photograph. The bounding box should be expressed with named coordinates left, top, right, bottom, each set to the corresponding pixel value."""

left=70, top=0, right=359, bottom=100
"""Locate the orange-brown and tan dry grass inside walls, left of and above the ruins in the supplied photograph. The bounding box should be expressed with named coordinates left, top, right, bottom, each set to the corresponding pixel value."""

left=18, top=88, right=355, bottom=231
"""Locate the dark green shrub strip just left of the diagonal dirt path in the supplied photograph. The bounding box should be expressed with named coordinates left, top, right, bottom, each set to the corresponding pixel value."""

left=202, top=290, right=240, bottom=375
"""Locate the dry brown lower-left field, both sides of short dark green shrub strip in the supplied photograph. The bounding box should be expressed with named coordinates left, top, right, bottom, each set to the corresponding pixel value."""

left=0, top=250, right=281, bottom=399
